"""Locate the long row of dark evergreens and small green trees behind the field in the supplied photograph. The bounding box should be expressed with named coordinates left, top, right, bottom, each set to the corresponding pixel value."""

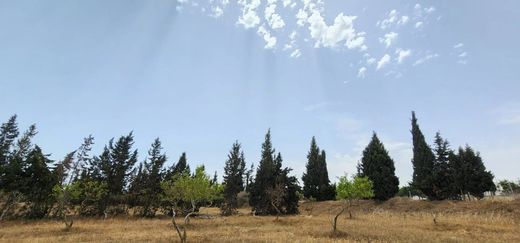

left=0, top=112, right=500, bottom=220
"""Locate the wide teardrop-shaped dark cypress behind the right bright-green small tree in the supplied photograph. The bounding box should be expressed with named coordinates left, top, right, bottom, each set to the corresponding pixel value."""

left=358, top=132, right=399, bottom=201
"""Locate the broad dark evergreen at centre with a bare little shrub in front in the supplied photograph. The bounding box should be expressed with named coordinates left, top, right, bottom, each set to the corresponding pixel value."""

left=249, top=130, right=298, bottom=215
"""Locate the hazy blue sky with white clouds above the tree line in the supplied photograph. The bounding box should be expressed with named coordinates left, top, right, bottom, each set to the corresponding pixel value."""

left=0, top=0, right=520, bottom=185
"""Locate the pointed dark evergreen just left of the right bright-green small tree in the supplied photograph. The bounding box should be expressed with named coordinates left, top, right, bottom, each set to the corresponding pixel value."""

left=302, top=137, right=335, bottom=201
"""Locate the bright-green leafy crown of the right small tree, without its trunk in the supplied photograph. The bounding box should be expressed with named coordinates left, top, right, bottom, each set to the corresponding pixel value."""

left=336, top=176, right=374, bottom=201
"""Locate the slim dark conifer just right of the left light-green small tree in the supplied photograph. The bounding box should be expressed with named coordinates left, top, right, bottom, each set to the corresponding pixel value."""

left=221, top=141, right=246, bottom=215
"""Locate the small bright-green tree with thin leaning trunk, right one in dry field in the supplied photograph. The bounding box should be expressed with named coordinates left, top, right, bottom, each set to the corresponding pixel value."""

left=332, top=176, right=374, bottom=233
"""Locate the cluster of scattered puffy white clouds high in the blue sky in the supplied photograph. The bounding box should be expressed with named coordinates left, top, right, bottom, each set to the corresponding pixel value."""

left=176, top=0, right=469, bottom=79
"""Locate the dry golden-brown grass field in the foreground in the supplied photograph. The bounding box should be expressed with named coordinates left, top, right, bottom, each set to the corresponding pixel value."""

left=0, top=198, right=520, bottom=242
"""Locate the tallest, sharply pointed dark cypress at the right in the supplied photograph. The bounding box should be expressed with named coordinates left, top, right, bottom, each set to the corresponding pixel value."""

left=411, top=111, right=435, bottom=198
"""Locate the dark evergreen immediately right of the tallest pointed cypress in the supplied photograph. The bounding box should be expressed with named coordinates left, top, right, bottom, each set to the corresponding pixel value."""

left=431, top=132, right=454, bottom=200
